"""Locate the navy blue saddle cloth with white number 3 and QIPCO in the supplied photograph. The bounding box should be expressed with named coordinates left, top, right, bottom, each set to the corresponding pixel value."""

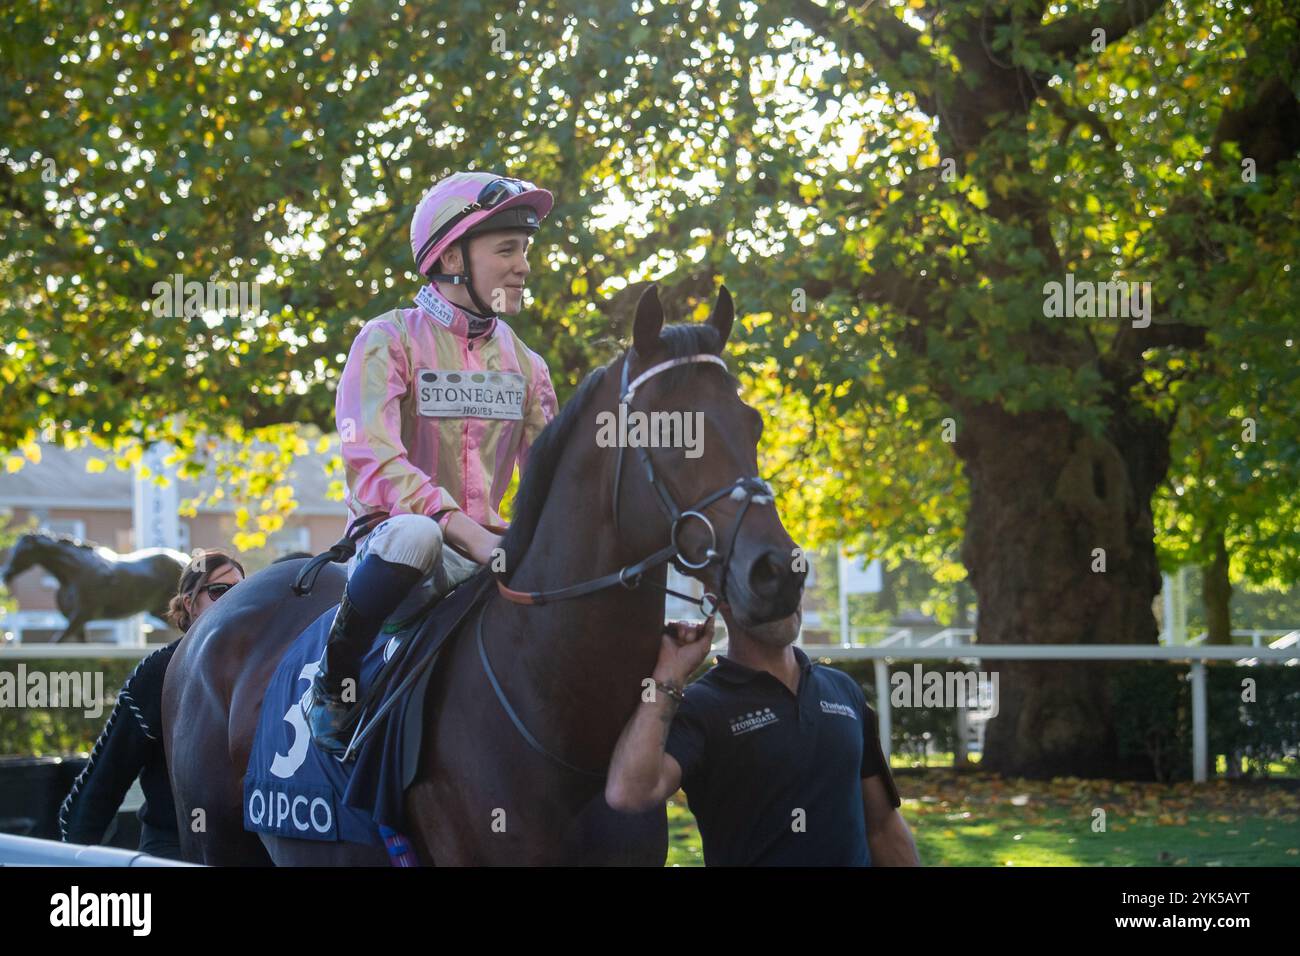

left=243, top=574, right=491, bottom=847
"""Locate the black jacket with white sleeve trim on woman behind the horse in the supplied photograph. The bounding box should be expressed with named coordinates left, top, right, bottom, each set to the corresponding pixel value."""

left=59, top=640, right=181, bottom=845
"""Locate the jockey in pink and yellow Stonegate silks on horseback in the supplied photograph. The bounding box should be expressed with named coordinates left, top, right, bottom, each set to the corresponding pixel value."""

left=302, top=173, right=556, bottom=756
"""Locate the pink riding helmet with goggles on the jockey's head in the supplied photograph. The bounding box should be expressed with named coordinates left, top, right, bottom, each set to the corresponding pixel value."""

left=411, top=173, right=555, bottom=276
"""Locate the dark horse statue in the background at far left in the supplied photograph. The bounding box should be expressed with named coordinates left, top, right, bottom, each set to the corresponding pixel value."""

left=0, top=535, right=190, bottom=644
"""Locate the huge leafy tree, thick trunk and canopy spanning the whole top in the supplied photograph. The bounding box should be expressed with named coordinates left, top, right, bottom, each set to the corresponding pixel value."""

left=0, top=0, right=1300, bottom=775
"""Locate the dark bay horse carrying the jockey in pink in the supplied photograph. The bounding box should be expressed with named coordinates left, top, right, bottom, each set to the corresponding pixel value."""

left=164, top=287, right=803, bottom=866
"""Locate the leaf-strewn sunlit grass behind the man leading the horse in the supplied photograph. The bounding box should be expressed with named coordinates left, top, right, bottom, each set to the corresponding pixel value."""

left=668, top=758, right=1300, bottom=866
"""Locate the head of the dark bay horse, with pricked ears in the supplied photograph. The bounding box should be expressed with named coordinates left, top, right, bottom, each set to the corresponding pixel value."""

left=611, top=286, right=805, bottom=624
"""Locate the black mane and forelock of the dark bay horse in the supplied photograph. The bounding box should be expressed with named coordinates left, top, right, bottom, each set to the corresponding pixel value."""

left=501, top=323, right=740, bottom=568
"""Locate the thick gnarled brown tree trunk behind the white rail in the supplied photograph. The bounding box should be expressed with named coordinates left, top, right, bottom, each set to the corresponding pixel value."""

left=957, top=405, right=1169, bottom=778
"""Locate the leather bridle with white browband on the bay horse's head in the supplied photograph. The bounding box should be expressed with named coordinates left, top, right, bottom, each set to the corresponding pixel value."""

left=497, top=355, right=772, bottom=618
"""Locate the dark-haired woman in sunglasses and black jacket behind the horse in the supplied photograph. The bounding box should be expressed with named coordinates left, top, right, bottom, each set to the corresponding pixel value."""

left=59, top=548, right=244, bottom=860
